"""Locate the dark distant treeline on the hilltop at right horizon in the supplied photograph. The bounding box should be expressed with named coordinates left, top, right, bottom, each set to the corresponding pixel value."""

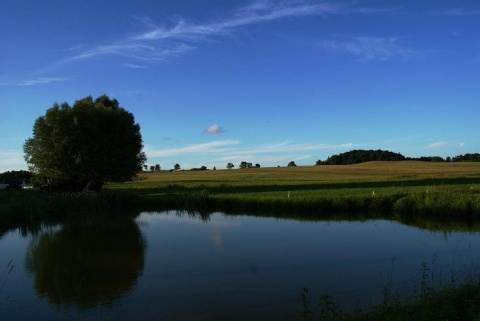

left=316, top=149, right=480, bottom=165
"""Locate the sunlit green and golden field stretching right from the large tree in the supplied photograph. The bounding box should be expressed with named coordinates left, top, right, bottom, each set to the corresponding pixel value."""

left=111, top=162, right=480, bottom=216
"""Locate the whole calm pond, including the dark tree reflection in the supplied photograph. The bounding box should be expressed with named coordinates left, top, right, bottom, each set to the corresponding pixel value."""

left=0, top=211, right=480, bottom=320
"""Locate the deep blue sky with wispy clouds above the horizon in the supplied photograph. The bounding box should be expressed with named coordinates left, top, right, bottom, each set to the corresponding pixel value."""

left=0, top=0, right=480, bottom=172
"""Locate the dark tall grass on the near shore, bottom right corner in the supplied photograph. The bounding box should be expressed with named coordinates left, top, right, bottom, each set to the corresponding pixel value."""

left=297, top=263, right=480, bottom=321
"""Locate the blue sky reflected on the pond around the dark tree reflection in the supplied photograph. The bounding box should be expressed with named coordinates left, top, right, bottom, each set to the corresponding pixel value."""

left=0, top=212, right=480, bottom=320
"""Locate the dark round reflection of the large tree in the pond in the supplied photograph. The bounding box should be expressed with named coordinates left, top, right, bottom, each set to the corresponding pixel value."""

left=25, top=219, right=146, bottom=309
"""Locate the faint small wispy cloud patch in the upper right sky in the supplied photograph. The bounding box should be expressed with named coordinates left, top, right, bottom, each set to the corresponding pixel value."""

left=321, top=37, right=419, bottom=61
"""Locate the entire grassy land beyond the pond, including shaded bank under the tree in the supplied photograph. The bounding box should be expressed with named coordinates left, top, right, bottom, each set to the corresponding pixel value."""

left=0, top=161, right=480, bottom=231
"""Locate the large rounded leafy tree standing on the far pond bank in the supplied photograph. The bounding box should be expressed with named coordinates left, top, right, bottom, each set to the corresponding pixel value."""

left=23, top=95, right=146, bottom=191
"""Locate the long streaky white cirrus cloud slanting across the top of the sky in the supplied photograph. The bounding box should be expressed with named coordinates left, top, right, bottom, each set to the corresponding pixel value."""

left=61, top=0, right=384, bottom=64
